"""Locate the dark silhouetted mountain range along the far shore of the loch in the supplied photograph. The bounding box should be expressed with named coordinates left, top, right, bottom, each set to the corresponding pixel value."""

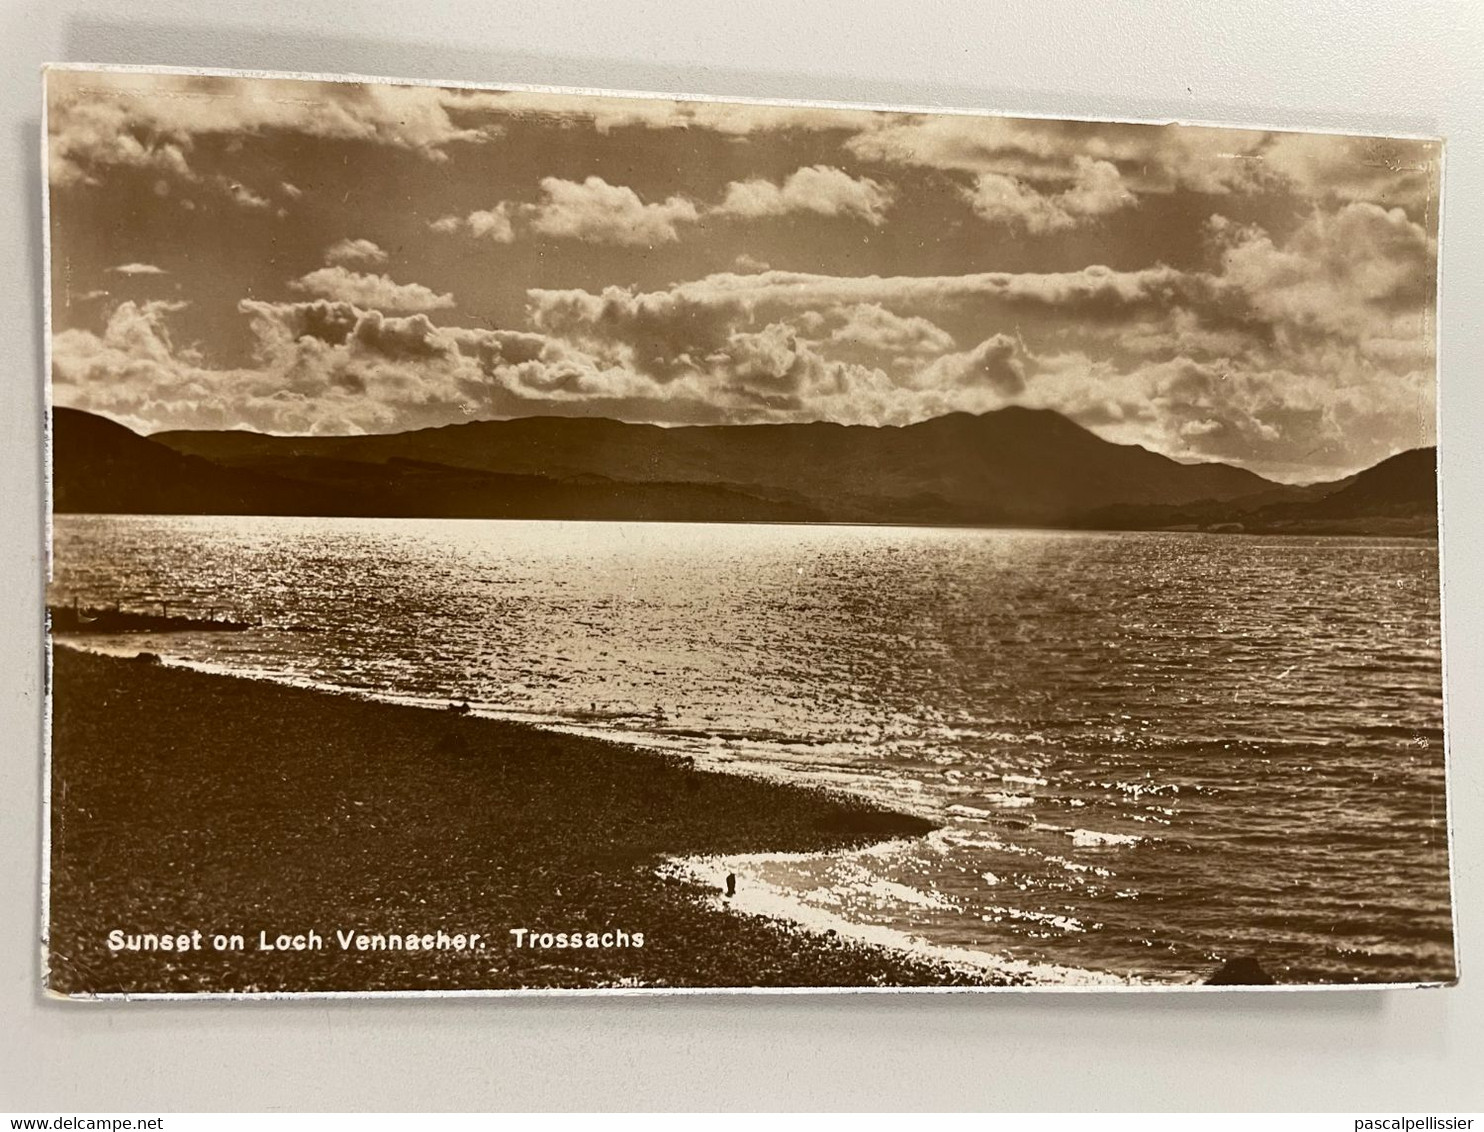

left=52, top=408, right=1437, bottom=534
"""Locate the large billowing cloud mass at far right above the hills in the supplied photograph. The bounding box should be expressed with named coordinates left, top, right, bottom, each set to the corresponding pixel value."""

left=985, top=202, right=1437, bottom=481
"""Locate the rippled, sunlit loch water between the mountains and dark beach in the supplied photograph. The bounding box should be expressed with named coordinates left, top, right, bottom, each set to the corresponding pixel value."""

left=52, top=516, right=1453, bottom=982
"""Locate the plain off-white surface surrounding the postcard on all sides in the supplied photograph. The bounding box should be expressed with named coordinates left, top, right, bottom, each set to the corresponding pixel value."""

left=0, top=0, right=1484, bottom=1113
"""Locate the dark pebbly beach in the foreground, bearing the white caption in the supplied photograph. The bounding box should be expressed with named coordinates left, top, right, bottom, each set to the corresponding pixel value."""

left=49, top=647, right=1003, bottom=994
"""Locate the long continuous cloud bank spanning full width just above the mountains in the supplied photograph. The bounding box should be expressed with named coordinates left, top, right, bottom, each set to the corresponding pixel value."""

left=53, top=184, right=1437, bottom=479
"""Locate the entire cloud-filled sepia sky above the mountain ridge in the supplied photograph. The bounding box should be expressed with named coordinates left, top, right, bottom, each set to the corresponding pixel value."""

left=47, top=71, right=1439, bottom=481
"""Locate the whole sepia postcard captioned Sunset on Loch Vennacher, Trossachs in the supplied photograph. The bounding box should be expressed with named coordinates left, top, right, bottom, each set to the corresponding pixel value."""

left=43, top=67, right=1457, bottom=998
